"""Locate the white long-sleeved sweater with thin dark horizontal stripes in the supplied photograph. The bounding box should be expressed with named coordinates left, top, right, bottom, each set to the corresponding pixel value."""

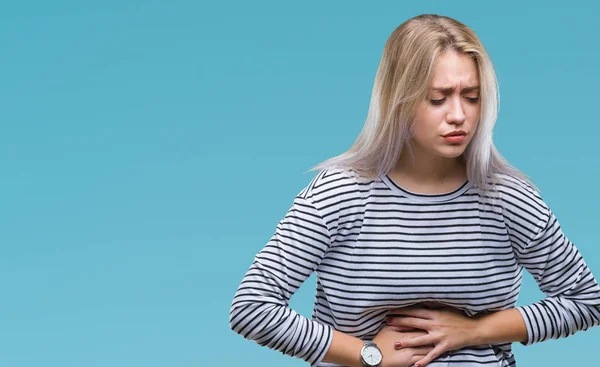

left=230, top=170, right=600, bottom=367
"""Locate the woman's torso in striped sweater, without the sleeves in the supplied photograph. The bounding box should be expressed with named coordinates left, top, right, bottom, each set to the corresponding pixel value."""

left=313, top=171, right=521, bottom=366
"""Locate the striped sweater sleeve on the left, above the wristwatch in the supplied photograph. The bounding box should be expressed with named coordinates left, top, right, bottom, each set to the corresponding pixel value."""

left=230, top=195, right=333, bottom=365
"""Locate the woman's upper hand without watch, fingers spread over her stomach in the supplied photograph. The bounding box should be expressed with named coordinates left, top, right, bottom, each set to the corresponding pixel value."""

left=388, top=307, right=477, bottom=367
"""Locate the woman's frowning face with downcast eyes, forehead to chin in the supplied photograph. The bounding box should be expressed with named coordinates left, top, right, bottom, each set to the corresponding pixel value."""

left=411, top=50, right=480, bottom=158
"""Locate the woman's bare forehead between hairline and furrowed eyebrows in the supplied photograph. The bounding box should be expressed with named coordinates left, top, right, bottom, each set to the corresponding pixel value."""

left=431, top=50, right=479, bottom=88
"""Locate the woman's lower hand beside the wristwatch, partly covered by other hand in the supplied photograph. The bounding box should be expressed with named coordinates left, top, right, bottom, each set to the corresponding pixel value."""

left=373, top=326, right=433, bottom=367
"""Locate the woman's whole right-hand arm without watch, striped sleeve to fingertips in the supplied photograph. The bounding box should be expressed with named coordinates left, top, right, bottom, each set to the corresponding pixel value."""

left=391, top=184, right=600, bottom=366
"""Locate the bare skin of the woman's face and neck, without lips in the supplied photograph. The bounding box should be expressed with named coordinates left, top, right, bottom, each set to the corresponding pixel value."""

left=389, top=50, right=481, bottom=194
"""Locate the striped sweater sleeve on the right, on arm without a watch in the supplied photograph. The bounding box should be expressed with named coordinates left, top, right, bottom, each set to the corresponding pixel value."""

left=508, top=184, right=600, bottom=345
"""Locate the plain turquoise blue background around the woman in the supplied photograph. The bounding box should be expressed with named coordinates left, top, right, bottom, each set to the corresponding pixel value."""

left=0, top=0, right=600, bottom=367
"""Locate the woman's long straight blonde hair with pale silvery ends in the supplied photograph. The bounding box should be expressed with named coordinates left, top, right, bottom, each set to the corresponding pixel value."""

left=313, top=14, right=529, bottom=193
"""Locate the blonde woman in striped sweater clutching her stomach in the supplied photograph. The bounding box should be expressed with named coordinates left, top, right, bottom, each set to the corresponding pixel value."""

left=230, top=15, right=600, bottom=367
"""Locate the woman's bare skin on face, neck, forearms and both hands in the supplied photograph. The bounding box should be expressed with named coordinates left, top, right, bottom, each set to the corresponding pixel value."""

left=323, top=50, right=528, bottom=367
